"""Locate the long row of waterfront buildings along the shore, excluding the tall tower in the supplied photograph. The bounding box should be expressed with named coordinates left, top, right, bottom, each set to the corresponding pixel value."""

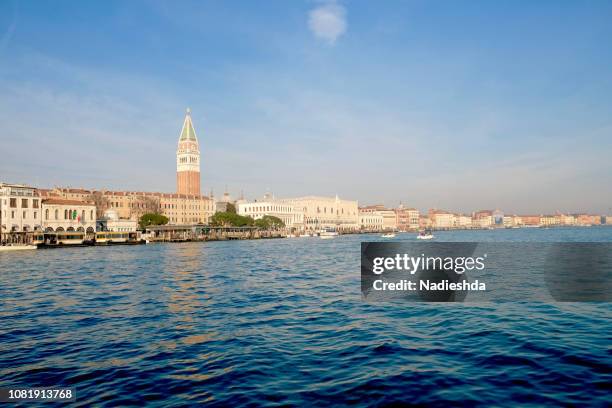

left=0, top=183, right=612, bottom=241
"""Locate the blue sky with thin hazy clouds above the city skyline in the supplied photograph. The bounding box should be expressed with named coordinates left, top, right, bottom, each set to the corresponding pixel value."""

left=0, top=0, right=612, bottom=213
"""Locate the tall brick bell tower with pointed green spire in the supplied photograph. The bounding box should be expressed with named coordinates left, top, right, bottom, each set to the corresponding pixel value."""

left=176, top=108, right=200, bottom=195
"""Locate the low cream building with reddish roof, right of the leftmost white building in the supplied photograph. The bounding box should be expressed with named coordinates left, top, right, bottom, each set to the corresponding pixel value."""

left=42, top=198, right=96, bottom=233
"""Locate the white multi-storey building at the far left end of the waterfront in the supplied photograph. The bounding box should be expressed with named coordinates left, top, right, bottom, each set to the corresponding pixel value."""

left=0, top=183, right=42, bottom=241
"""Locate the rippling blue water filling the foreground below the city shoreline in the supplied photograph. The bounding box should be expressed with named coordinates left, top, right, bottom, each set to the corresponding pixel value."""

left=0, top=227, right=612, bottom=406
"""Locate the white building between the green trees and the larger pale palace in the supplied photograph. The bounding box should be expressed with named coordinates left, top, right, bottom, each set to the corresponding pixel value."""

left=236, top=197, right=304, bottom=231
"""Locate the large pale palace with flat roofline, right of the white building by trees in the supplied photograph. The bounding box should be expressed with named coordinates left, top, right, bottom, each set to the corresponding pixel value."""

left=281, top=196, right=358, bottom=232
